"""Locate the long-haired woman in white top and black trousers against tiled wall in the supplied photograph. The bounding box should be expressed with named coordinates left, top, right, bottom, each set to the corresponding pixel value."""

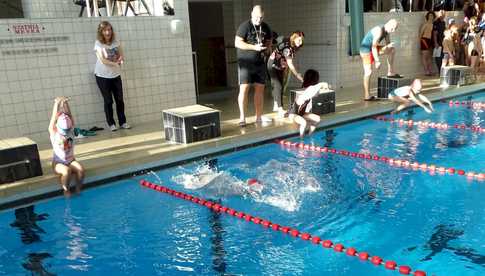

left=94, top=21, right=130, bottom=131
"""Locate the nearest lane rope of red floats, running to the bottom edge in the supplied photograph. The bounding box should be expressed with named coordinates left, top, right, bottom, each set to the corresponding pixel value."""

left=140, top=180, right=426, bottom=276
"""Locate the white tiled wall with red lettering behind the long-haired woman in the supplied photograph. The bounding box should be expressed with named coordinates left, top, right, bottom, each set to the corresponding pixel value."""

left=0, top=0, right=195, bottom=140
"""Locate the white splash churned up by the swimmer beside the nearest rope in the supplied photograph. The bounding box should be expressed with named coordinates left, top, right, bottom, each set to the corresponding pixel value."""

left=172, top=160, right=321, bottom=212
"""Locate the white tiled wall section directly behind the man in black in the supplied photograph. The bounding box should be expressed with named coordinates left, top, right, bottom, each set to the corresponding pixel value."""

left=224, top=0, right=338, bottom=86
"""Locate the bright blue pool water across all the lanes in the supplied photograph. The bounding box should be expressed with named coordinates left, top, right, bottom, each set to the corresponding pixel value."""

left=0, top=93, right=485, bottom=275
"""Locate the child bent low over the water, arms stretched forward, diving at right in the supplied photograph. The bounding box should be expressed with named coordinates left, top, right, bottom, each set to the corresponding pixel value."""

left=388, top=79, right=434, bottom=114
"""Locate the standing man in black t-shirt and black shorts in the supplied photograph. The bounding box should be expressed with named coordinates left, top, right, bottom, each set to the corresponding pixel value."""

left=234, top=5, right=272, bottom=126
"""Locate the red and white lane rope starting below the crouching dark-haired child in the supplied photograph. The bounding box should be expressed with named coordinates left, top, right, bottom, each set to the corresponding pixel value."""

left=275, top=140, right=485, bottom=181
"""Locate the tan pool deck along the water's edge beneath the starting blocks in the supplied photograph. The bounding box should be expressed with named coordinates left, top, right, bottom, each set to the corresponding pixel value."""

left=0, top=77, right=485, bottom=210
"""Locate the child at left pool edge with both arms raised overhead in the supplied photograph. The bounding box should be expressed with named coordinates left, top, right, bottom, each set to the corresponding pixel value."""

left=49, top=97, right=84, bottom=196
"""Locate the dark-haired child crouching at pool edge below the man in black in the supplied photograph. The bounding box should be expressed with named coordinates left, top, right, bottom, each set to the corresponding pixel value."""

left=289, top=69, right=329, bottom=137
